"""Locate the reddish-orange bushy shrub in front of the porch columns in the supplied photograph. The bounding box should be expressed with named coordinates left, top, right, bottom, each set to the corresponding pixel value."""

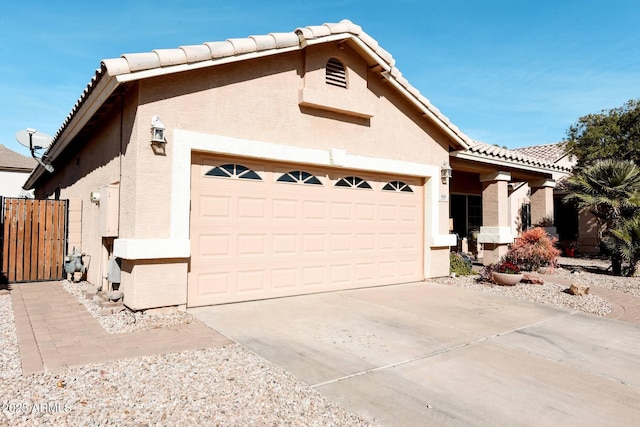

left=504, top=227, right=560, bottom=271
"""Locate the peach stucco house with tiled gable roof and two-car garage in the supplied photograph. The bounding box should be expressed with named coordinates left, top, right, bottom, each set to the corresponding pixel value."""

left=27, top=21, right=562, bottom=309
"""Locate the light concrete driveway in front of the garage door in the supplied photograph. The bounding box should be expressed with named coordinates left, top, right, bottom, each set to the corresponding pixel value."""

left=190, top=283, right=640, bottom=426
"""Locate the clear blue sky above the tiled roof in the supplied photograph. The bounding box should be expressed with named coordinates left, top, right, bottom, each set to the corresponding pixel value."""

left=0, top=0, right=640, bottom=158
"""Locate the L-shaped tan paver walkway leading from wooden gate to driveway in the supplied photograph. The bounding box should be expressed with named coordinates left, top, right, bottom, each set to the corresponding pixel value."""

left=11, top=282, right=232, bottom=374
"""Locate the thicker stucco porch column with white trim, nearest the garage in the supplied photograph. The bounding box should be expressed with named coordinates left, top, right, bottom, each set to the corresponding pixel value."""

left=478, top=172, right=513, bottom=265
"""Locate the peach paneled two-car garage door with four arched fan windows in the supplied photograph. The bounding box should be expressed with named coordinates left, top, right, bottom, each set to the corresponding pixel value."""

left=187, top=154, right=424, bottom=307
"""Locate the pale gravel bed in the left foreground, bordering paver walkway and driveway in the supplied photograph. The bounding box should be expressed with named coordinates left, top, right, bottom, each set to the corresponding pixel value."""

left=0, top=295, right=373, bottom=426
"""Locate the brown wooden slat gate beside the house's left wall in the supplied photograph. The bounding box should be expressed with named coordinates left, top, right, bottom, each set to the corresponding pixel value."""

left=0, top=198, right=68, bottom=283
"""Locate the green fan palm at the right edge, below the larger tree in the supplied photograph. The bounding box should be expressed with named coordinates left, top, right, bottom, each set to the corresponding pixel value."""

left=564, top=159, right=640, bottom=275
